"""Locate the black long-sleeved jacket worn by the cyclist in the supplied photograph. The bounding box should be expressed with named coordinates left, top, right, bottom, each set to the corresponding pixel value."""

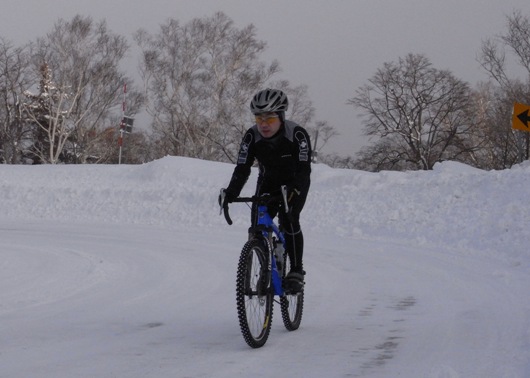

left=227, top=121, right=311, bottom=196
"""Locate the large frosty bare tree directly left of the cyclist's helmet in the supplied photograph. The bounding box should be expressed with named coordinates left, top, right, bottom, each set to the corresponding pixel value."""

left=135, top=13, right=279, bottom=161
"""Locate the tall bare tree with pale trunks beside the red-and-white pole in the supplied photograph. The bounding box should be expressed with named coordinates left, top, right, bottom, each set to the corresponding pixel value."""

left=25, top=16, right=142, bottom=163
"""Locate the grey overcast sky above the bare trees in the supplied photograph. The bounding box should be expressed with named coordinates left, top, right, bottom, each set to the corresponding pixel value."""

left=0, top=0, right=530, bottom=155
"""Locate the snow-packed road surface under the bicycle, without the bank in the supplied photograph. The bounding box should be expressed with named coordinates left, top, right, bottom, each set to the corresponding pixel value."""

left=0, top=222, right=530, bottom=378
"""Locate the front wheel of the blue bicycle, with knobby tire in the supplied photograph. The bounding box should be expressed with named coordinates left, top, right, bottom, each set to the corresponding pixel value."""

left=236, top=239, right=273, bottom=348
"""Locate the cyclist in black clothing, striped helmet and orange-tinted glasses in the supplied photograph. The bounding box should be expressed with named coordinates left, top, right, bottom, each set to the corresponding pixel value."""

left=219, top=89, right=311, bottom=292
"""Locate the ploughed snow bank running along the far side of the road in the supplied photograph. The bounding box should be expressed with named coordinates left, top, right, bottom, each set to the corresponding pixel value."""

left=0, top=157, right=530, bottom=266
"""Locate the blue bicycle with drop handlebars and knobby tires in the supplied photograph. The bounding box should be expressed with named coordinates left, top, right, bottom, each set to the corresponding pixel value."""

left=221, top=187, right=304, bottom=348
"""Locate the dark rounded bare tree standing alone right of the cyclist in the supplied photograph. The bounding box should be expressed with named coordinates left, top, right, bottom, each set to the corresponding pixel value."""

left=349, top=54, right=474, bottom=170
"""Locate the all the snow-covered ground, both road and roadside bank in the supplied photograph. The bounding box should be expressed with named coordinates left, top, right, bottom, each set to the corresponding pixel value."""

left=0, top=157, right=530, bottom=378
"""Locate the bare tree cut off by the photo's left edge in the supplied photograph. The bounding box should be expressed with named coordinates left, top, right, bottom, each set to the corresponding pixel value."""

left=0, top=38, right=30, bottom=164
